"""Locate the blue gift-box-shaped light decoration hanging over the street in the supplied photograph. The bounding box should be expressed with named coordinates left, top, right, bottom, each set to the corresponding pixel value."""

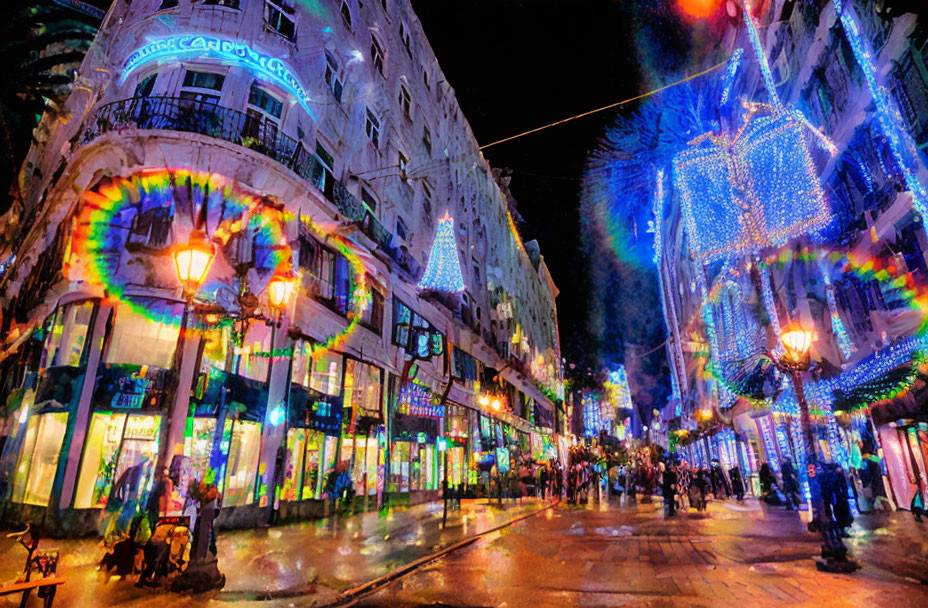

left=673, top=103, right=833, bottom=262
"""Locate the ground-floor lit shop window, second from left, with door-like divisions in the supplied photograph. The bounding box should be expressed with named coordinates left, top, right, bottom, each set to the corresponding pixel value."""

left=74, top=412, right=161, bottom=509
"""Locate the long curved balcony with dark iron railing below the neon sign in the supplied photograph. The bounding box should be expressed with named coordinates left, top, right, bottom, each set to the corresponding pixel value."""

left=82, top=97, right=418, bottom=274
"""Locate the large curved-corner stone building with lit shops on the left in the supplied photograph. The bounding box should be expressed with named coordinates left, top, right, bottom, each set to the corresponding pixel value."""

left=0, top=0, right=563, bottom=533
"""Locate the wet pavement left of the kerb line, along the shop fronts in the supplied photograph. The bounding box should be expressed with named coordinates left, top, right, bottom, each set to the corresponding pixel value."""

left=0, top=500, right=544, bottom=608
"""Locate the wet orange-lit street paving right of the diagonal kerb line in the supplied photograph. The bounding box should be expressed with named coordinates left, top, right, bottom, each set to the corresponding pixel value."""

left=356, top=500, right=928, bottom=608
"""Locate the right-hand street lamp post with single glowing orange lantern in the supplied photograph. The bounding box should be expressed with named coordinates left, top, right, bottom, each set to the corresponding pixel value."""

left=771, top=326, right=859, bottom=572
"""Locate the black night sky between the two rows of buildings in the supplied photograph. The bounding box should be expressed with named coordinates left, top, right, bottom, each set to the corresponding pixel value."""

left=412, top=0, right=639, bottom=370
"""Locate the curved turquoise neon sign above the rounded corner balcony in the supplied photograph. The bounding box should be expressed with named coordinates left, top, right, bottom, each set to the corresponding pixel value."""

left=120, top=34, right=316, bottom=120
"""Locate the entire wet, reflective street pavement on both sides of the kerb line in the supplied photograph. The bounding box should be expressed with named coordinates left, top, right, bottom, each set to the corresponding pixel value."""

left=0, top=501, right=928, bottom=608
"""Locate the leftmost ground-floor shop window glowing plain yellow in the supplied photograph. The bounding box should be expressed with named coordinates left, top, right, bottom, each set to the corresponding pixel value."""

left=13, top=412, right=68, bottom=507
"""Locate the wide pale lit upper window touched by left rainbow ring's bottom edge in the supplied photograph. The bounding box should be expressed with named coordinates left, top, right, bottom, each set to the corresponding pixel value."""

left=105, top=300, right=183, bottom=369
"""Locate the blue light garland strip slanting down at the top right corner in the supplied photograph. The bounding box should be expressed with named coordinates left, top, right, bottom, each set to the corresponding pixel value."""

left=834, top=0, right=928, bottom=218
